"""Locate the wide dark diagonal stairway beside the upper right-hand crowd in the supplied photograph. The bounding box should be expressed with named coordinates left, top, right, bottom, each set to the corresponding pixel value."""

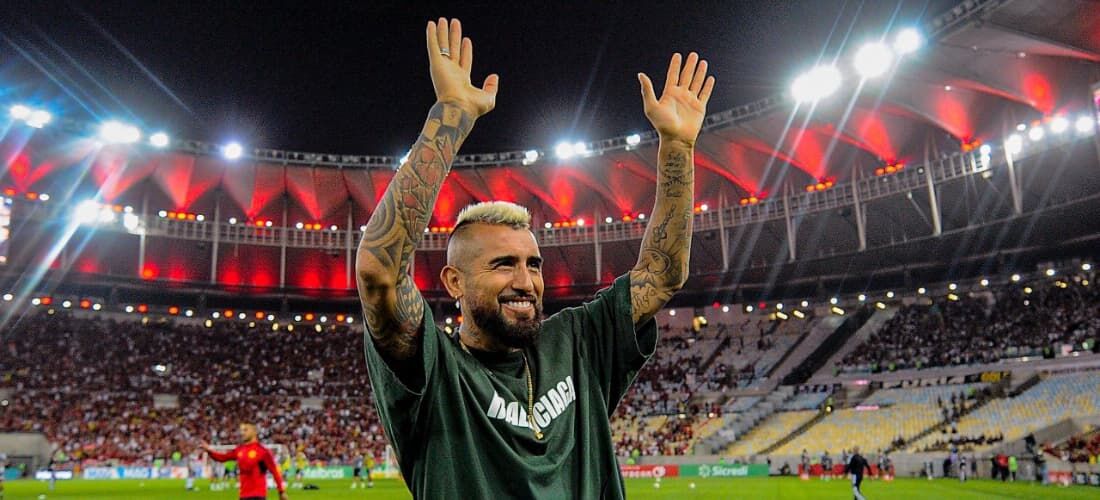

left=776, top=307, right=873, bottom=386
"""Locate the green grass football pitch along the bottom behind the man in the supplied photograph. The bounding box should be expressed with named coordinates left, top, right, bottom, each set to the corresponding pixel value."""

left=4, top=478, right=1100, bottom=500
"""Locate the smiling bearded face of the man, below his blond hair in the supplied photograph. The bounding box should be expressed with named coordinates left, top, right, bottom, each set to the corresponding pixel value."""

left=440, top=223, right=543, bottom=351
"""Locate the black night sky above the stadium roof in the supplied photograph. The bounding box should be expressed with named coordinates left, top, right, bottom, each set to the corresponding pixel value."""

left=0, top=0, right=956, bottom=155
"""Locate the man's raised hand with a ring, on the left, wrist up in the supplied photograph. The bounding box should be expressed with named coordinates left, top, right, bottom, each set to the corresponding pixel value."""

left=427, top=18, right=501, bottom=118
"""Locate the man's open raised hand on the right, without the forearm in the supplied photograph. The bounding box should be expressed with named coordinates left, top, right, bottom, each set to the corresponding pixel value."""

left=638, top=52, right=714, bottom=144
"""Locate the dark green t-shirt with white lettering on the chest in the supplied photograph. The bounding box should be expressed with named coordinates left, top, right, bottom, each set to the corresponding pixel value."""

left=365, top=276, right=657, bottom=499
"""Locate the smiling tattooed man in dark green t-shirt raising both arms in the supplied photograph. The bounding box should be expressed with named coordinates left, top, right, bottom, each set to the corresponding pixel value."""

left=356, top=19, right=714, bottom=499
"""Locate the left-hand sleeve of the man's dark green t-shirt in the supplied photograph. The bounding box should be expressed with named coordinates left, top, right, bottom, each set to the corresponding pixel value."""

left=363, top=299, right=442, bottom=456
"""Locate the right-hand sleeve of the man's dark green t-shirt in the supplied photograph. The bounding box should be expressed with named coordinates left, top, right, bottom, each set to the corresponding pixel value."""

left=562, top=275, right=658, bottom=416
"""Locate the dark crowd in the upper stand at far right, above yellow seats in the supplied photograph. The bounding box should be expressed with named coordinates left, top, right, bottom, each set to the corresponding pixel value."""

left=842, top=277, right=1100, bottom=373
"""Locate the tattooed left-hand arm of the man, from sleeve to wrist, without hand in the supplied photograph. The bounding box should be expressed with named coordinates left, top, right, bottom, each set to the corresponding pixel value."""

left=355, top=102, right=475, bottom=359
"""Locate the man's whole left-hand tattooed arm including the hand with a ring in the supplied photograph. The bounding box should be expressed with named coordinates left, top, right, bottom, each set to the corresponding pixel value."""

left=355, top=18, right=498, bottom=360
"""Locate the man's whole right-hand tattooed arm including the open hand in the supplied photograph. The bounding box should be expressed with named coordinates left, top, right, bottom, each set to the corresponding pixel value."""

left=629, top=53, right=714, bottom=324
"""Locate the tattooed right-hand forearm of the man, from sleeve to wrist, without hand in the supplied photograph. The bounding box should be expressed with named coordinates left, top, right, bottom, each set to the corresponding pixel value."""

left=630, top=142, right=695, bottom=324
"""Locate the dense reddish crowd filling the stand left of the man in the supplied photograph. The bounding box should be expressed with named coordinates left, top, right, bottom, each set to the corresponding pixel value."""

left=0, top=312, right=385, bottom=463
